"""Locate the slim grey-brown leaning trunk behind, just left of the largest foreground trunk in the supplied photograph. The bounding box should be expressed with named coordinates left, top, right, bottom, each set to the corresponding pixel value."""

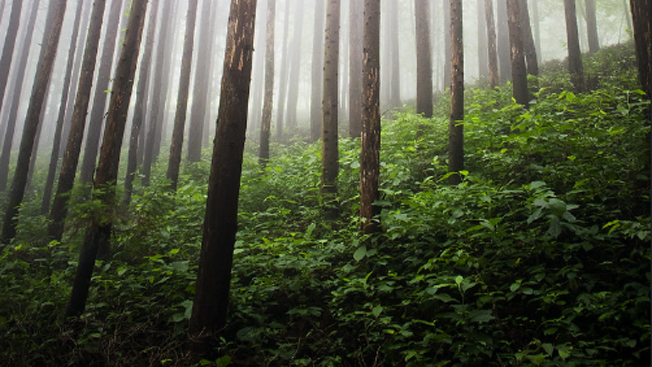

left=167, top=0, right=197, bottom=191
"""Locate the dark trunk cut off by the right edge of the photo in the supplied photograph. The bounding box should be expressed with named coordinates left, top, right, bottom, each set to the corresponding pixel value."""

left=630, top=0, right=652, bottom=99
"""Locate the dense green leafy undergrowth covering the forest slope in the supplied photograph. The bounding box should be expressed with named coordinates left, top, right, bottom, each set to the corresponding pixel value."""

left=0, top=43, right=650, bottom=367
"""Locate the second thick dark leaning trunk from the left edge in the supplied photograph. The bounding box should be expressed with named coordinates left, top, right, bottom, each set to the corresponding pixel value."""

left=48, top=0, right=106, bottom=241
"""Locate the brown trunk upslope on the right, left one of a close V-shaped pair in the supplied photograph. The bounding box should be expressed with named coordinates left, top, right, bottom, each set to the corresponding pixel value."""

left=507, top=0, right=530, bottom=106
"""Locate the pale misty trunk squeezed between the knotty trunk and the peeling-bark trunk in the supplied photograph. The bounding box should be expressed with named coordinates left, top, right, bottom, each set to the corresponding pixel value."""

left=349, top=0, right=364, bottom=138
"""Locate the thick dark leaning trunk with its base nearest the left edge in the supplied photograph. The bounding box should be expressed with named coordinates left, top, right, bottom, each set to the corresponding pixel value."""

left=0, top=0, right=66, bottom=244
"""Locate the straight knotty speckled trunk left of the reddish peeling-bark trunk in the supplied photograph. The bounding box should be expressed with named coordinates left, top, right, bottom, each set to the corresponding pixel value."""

left=321, top=0, right=340, bottom=219
